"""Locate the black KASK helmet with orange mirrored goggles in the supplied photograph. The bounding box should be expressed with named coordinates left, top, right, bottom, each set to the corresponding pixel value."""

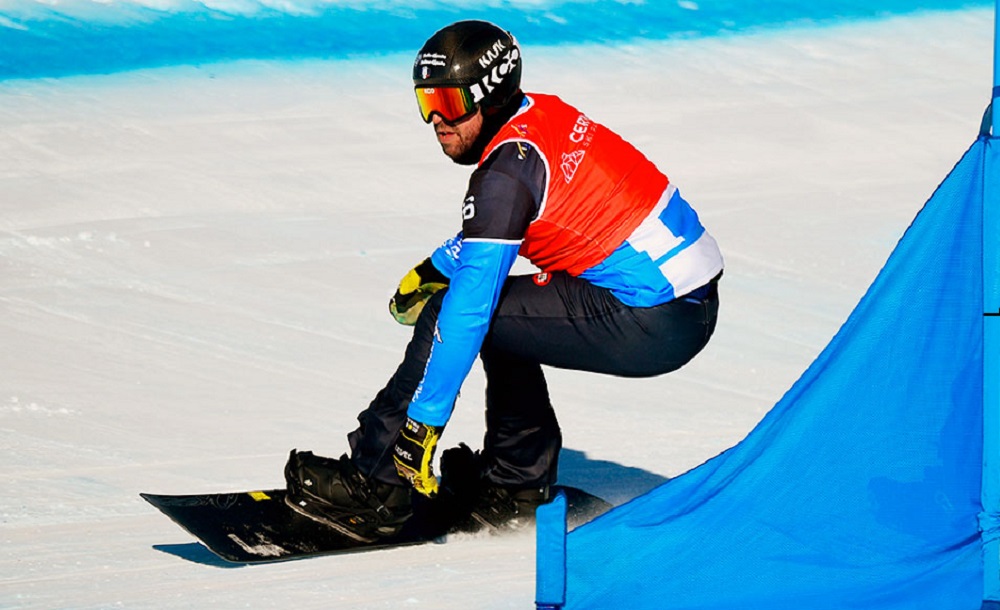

left=413, top=21, right=521, bottom=123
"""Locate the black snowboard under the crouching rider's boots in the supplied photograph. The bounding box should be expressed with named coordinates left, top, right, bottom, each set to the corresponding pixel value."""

left=139, top=486, right=611, bottom=564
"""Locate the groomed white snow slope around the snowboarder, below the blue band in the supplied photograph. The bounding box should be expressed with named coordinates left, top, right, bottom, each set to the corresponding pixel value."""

left=0, top=9, right=993, bottom=609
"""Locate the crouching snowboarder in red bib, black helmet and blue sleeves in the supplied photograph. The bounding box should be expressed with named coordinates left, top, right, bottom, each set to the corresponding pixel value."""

left=285, top=21, right=723, bottom=540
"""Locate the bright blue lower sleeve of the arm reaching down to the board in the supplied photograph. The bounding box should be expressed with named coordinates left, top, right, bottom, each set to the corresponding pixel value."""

left=407, top=240, right=519, bottom=426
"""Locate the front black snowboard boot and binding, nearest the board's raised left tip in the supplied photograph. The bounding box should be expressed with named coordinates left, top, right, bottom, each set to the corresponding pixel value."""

left=285, top=449, right=412, bottom=542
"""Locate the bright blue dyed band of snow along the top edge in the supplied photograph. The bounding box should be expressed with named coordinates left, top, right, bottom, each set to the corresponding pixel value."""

left=0, top=0, right=989, bottom=79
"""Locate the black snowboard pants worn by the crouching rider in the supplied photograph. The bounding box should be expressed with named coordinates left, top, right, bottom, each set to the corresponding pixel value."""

left=348, top=273, right=719, bottom=487
